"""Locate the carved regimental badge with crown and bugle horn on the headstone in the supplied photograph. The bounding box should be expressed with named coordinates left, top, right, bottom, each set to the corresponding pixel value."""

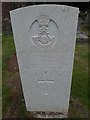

left=32, top=15, right=58, bottom=47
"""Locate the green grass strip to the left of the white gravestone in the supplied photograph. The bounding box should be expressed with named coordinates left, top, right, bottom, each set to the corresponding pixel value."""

left=2, top=34, right=15, bottom=116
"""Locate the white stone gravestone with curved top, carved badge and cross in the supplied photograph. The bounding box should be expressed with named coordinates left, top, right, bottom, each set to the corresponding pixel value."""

left=10, top=5, right=79, bottom=118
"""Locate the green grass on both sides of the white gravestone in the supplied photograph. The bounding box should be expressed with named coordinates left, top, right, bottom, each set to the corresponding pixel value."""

left=2, top=34, right=90, bottom=116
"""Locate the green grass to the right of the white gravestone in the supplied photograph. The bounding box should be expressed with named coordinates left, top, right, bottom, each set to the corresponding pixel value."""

left=71, top=44, right=88, bottom=106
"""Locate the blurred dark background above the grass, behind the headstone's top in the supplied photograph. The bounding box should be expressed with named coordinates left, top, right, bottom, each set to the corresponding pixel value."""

left=2, top=2, right=90, bottom=38
